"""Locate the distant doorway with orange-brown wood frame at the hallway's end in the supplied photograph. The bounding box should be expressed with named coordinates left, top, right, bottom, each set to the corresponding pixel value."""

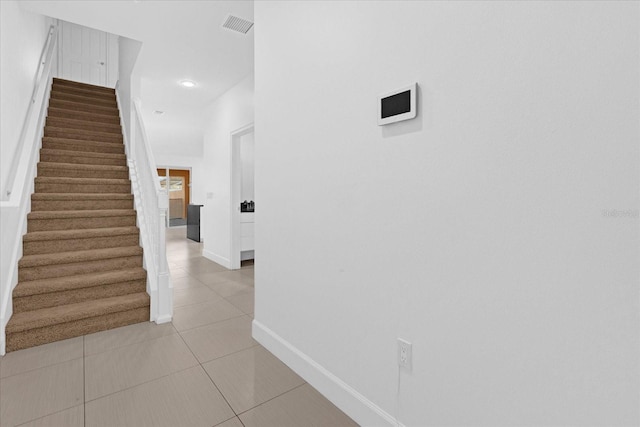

left=158, top=168, right=191, bottom=227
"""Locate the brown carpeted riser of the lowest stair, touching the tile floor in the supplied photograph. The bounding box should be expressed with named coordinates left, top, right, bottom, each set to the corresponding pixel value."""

left=7, top=307, right=150, bottom=351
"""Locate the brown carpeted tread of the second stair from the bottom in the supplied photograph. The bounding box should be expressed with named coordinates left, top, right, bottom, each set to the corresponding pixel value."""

left=13, top=267, right=147, bottom=298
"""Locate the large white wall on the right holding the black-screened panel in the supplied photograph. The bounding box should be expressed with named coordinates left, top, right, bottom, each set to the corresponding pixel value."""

left=255, top=2, right=640, bottom=426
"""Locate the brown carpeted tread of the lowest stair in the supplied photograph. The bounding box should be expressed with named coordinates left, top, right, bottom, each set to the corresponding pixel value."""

left=6, top=292, right=149, bottom=334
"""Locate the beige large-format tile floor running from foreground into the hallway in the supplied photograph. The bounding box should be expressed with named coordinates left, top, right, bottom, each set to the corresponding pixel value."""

left=0, top=227, right=357, bottom=427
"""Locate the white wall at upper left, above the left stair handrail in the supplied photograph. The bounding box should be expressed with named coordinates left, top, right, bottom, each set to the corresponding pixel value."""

left=0, top=0, right=52, bottom=195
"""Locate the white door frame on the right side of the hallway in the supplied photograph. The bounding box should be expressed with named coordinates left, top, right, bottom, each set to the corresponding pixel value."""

left=229, top=122, right=254, bottom=270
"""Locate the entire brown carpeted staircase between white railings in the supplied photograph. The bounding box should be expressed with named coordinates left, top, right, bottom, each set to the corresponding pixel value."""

left=6, top=79, right=150, bottom=351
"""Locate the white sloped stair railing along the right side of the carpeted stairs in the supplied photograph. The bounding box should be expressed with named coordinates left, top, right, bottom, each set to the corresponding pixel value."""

left=116, top=91, right=173, bottom=323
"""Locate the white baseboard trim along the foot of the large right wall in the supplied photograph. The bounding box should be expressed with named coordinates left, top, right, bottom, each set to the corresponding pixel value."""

left=252, top=320, right=405, bottom=427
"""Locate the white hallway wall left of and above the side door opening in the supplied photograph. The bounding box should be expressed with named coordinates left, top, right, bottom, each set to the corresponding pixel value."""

left=201, top=75, right=254, bottom=267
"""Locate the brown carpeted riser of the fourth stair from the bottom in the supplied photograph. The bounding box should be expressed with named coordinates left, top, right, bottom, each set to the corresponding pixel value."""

left=22, top=234, right=140, bottom=255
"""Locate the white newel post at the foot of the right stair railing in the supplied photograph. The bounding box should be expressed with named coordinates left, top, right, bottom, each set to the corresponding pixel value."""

left=156, top=191, right=173, bottom=324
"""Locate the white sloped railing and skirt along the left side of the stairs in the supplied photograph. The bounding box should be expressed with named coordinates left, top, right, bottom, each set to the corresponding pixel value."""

left=0, top=25, right=58, bottom=355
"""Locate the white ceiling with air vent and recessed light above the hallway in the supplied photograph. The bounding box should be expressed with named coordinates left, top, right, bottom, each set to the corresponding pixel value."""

left=20, top=0, right=253, bottom=156
